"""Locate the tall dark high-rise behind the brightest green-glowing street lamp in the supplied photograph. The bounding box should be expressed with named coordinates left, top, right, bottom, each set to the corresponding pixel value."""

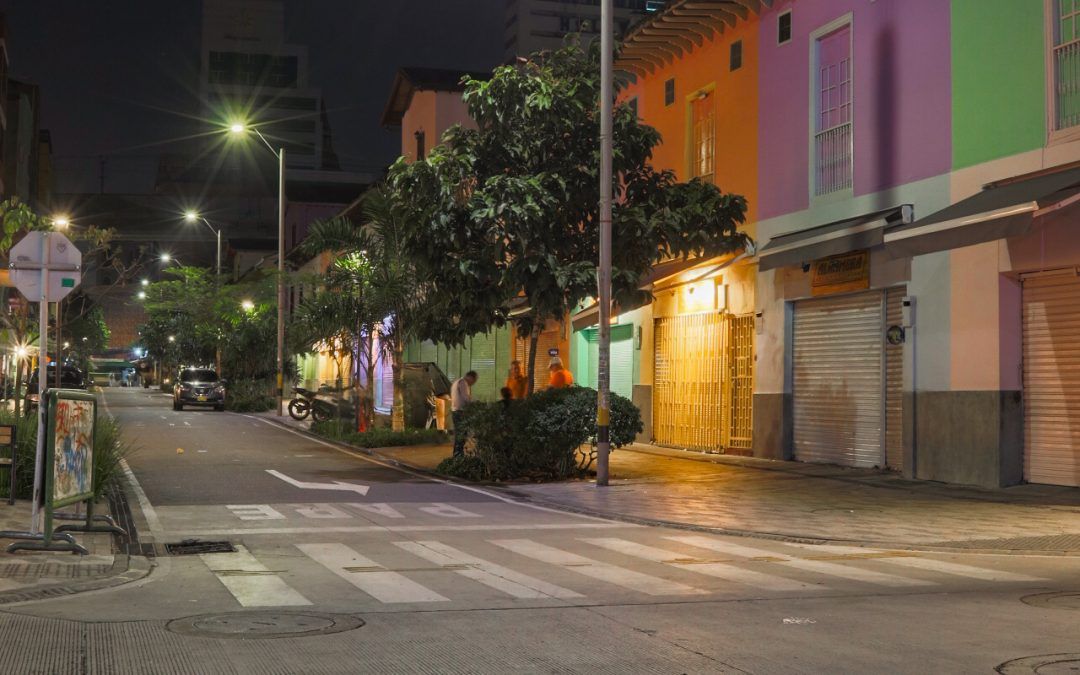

left=200, top=0, right=338, bottom=168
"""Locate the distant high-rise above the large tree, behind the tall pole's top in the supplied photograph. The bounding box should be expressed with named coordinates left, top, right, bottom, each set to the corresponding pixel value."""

left=503, top=0, right=664, bottom=62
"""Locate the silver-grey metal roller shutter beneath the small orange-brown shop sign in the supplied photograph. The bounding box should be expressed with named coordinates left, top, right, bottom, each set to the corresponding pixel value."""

left=792, top=292, right=885, bottom=467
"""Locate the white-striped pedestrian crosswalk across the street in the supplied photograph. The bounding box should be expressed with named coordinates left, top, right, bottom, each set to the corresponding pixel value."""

left=200, top=534, right=1047, bottom=607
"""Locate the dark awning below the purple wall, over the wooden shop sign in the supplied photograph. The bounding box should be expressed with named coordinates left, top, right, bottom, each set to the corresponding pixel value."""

left=758, top=204, right=913, bottom=272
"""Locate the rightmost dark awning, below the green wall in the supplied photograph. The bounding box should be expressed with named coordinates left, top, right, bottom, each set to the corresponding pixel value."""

left=885, top=162, right=1080, bottom=258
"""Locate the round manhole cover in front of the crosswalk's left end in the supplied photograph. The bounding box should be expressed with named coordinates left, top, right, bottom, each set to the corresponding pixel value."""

left=168, top=611, right=364, bottom=639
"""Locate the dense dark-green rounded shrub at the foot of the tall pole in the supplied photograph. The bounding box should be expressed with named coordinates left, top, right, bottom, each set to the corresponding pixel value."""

left=438, top=387, right=643, bottom=481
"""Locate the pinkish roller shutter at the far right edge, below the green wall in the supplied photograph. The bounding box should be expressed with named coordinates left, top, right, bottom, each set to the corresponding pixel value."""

left=1024, top=273, right=1080, bottom=487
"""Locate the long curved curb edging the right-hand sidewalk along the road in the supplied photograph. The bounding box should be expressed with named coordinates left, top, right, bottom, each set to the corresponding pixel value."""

left=257, top=418, right=1080, bottom=557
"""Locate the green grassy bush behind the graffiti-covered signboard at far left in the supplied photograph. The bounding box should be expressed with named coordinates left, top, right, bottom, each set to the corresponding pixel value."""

left=0, top=410, right=133, bottom=500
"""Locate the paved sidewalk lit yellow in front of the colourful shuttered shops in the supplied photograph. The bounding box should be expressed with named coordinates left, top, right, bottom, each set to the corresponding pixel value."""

left=377, top=446, right=1080, bottom=553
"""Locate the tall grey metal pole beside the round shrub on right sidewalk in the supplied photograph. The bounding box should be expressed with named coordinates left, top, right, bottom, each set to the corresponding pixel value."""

left=596, top=0, right=615, bottom=486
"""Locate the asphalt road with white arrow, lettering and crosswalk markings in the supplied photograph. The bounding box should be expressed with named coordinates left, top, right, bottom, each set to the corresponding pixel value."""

left=0, top=390, right=1080, bottom=673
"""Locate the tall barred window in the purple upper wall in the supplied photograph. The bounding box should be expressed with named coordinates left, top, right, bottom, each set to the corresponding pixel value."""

left=813, top=24, right=852, bottom=197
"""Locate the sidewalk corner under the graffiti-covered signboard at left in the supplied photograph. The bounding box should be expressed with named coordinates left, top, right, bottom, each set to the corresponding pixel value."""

left=0, top=499, right=135, bottom=605
